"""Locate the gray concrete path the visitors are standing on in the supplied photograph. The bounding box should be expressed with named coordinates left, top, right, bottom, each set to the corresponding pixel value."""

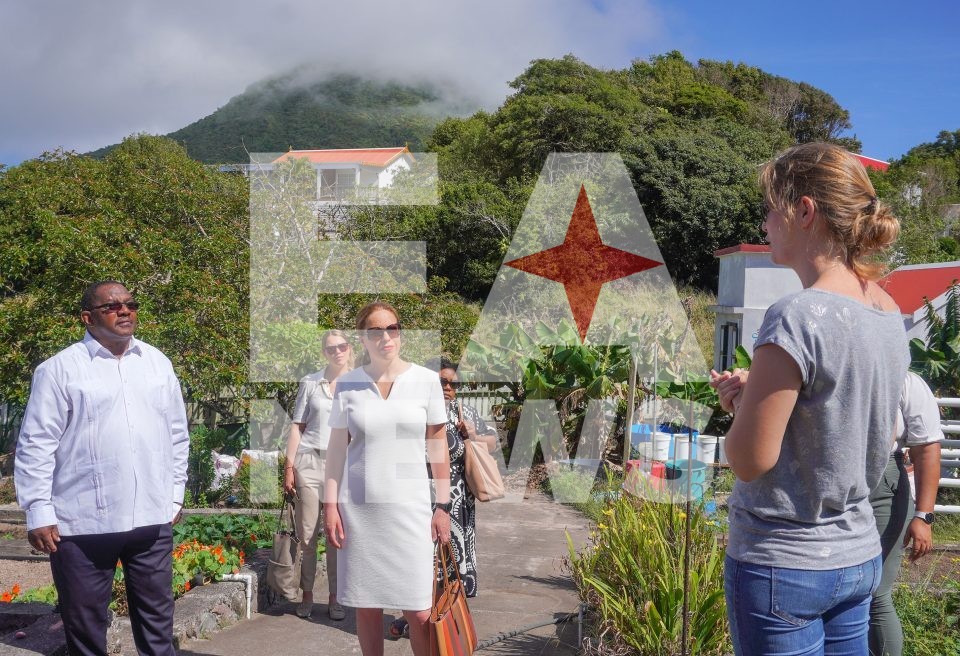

left=180, top=494, right=590, bottom=656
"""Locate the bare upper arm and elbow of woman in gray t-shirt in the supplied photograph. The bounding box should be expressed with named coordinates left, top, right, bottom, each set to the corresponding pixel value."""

left=725, top=344, right=803, bottom=482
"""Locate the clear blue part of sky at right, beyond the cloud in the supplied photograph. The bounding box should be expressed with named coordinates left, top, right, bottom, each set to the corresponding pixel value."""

left=665, top=0, right=960, bottom=159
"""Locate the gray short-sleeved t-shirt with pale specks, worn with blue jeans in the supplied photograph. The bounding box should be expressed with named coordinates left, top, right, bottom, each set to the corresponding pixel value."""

left=727, top=289, right=910, bottom=570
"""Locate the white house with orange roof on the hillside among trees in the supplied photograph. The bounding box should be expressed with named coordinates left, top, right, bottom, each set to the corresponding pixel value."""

left=271, top=147, right=414, bottom=203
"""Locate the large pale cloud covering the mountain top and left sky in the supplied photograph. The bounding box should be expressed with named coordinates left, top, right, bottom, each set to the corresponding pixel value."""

left=0, top=0, right=662, bottom=162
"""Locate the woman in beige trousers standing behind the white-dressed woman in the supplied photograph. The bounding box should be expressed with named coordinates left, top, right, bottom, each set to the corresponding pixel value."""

left=283, top=330, right=353, bottom=620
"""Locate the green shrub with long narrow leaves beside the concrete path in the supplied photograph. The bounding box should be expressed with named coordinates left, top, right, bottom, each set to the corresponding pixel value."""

left=570, top=495, right=731, bottom=655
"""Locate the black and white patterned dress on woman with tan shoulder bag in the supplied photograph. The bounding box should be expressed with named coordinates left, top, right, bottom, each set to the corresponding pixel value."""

left=447, top=401, right=497, bottom=597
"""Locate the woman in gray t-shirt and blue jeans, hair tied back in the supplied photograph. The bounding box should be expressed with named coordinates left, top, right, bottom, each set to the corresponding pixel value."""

left=714, top=143, right=909, bottom=656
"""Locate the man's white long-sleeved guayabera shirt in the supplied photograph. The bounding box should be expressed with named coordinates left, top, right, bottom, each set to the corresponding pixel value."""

left=15, top=333, right=190, bottom=535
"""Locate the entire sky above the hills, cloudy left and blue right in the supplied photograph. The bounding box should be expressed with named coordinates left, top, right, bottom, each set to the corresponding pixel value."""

left=0, top=0, right=960, bottom=165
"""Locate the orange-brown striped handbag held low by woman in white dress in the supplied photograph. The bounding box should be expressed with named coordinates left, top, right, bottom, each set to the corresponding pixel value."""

left=430, top=542, right=477, bottom=656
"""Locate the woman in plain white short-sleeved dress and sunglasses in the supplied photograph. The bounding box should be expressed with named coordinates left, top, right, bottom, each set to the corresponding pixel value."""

left=324, top=303, right=450, bottom=656
